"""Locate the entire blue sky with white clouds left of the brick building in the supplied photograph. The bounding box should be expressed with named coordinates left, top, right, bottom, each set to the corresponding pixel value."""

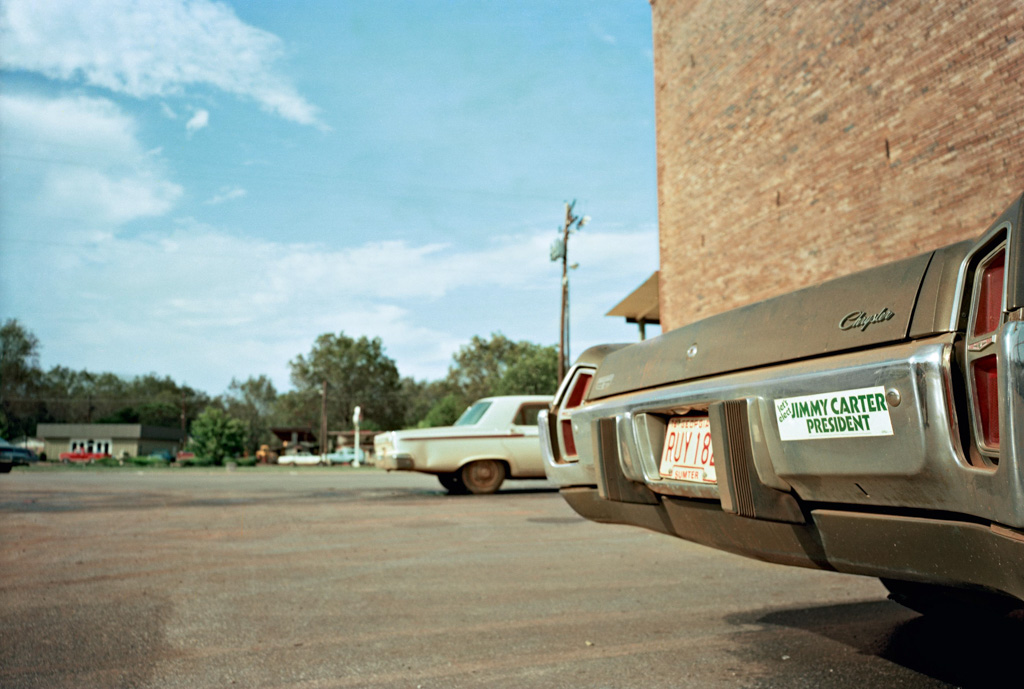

left=0, top=0, right=657, bottom=394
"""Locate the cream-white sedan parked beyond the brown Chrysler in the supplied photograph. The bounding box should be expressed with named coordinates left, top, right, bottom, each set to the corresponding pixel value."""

left=374, top=395, right=551, bottom=493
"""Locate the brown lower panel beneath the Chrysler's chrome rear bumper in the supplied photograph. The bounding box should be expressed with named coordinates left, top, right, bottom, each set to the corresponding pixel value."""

left=561, top=487, right=1024, bottom=599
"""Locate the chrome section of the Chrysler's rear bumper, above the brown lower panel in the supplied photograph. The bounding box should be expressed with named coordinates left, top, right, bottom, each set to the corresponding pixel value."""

left=544, top=322, right=1024, bottom=528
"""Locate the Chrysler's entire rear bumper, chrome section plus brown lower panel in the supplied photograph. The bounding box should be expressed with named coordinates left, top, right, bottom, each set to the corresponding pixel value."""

left=544, top=321, right=1024, bottom=598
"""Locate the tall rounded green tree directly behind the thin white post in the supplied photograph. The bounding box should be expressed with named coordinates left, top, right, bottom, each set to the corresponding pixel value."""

left=282, top=333, right=406, bottom=430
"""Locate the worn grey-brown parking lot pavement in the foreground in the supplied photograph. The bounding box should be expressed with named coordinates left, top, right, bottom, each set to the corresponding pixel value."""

left=0, top=468, right=1024, bottom=689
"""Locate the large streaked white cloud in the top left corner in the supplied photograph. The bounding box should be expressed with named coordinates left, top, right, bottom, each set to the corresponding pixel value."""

left=0, top=0, right=324, bottom=127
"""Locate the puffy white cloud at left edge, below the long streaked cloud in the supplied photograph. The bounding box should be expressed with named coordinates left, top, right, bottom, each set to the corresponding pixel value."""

left=0, top=95, right=182, bottom=231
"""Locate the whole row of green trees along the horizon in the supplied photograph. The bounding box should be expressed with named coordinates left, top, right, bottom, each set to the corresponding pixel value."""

left=0, top=319, right=558, bottom=455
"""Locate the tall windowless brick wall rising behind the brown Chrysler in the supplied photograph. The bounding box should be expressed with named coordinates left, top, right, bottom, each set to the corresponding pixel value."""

left=651, top=0, right=1024, bottom=330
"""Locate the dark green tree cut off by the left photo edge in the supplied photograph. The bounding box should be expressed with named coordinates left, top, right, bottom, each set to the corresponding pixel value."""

left=0, top=318, right=45, bottom=438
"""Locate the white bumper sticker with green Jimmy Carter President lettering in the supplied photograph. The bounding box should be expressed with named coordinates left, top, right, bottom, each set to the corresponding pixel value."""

left=775, top=386, right=893, bottom=440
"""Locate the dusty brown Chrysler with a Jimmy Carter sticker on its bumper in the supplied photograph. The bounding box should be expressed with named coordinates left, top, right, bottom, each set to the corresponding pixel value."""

left=539, top=193, right=1024, bottom=613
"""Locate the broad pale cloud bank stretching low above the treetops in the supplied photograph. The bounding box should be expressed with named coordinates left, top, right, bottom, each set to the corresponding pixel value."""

left=14, top=223, right=657, bottom=393
